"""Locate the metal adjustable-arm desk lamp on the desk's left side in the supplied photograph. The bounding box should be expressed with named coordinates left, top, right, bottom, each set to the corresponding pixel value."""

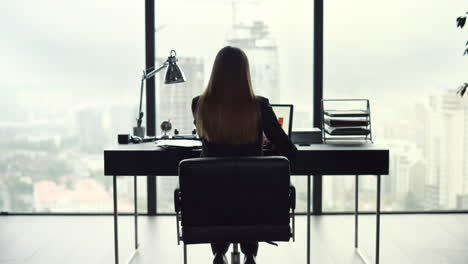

left=133, top=50, right=185, bottom=138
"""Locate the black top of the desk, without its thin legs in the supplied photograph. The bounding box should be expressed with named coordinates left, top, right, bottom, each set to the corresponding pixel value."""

left=104, top=142, right=389, bottom=176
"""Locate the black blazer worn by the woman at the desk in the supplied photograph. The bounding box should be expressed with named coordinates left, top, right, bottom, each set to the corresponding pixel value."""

left=192, top=96, right=297, bottom=160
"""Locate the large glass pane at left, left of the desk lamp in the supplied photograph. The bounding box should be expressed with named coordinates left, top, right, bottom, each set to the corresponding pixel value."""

left=0, top=0, right=146, bottom=212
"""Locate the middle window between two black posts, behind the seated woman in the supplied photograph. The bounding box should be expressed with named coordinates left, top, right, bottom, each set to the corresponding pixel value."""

left=155, top=0, right=313, bottom=212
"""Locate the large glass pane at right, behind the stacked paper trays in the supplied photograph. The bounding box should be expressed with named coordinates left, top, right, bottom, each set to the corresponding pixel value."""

left=324, top=0, right=468, bottom=211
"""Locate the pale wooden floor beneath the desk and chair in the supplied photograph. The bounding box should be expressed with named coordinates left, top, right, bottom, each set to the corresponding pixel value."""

left=0, top=214, right=468, bottom=264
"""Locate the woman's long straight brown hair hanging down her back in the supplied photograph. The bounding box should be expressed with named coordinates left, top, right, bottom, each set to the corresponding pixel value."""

left=196, top=46, right=260, bottom=145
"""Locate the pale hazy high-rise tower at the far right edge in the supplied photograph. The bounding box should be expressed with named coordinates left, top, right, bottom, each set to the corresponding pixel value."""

left=426, top=90, right=468, bottom=209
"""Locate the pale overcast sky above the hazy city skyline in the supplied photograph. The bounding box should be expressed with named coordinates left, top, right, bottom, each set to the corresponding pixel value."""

left=0, top=0, right=468, bottom=119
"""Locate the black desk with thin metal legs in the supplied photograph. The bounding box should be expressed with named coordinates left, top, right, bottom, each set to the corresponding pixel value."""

left=104, top=143, right=389, bottom=264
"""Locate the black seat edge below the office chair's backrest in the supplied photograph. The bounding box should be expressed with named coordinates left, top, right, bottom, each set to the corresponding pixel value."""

left=182, top=225, right=291, bottom=244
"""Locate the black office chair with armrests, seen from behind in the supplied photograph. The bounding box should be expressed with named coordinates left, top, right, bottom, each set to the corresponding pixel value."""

left=174, top=156, right=296, bottom=264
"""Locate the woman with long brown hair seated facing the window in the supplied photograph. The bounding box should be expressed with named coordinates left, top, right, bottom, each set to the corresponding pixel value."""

left=192, top=46, right=297, bottom=264
